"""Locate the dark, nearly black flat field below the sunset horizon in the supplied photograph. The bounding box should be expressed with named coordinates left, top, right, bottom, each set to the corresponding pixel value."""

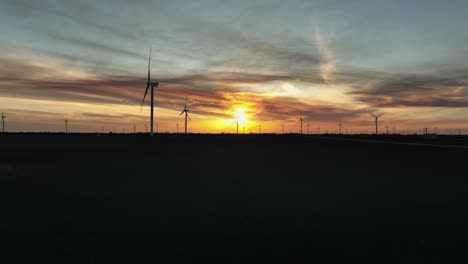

left=5, top=135, right=468, bottom=263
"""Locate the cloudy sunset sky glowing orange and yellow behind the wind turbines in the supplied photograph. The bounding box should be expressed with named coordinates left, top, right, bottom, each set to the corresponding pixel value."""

left=0, top=0, right=468, bottom=133
